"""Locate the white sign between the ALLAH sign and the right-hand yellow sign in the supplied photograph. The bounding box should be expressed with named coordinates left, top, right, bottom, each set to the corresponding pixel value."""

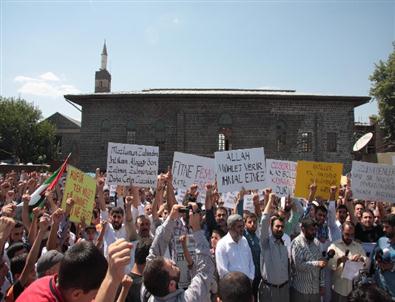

left=266, top=159, right=296, bottom=196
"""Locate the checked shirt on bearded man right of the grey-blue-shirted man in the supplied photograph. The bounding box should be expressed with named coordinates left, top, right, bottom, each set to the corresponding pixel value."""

left=291, top=233, right=325, bottom=294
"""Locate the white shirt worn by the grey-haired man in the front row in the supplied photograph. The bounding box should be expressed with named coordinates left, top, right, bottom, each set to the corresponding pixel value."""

left=215, top=233, right=255, bottom=280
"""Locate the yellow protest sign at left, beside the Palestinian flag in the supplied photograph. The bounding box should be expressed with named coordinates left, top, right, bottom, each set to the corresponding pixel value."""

left=62, top=165, right=96, bottom=225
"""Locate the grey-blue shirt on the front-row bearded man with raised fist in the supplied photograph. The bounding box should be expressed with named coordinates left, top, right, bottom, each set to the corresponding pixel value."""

left=261, top=214, right=289, bottom=285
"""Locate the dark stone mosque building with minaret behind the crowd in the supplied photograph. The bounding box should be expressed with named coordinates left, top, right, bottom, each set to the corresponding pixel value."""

left=65, top=44, right=370, bottom=171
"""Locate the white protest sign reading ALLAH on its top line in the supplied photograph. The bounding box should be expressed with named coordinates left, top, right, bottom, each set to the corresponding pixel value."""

left=215, top=148, right=266, bottom=193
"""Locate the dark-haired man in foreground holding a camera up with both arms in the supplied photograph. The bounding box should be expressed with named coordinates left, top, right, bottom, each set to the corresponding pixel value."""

left=142, top=204, right=214, bottom=302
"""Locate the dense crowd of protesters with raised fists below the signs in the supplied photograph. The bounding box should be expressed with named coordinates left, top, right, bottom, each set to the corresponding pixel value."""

left=0, top=169, right=395, bottom=302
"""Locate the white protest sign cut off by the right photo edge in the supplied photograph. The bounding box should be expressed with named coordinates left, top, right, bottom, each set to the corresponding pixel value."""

left=351, top=161, right=395, bottom=203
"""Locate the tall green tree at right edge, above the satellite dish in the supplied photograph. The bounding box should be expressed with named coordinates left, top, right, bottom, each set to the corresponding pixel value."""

left=369, top=42, right=395, bottom=145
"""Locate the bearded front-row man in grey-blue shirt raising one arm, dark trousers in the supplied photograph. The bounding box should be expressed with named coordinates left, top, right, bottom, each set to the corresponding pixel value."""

left=258, top=193, right=289, bottom=302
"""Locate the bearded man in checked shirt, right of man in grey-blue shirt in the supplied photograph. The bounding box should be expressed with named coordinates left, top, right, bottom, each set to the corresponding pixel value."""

left=291, top=217, right=327, bottom=302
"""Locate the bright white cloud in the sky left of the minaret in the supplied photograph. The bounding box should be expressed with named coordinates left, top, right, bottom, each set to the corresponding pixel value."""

left=14, top=71, right=80, bottom=98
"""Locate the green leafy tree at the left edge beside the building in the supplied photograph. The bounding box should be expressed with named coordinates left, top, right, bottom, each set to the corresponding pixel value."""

left=0, top=96, right=55, bottom=163
